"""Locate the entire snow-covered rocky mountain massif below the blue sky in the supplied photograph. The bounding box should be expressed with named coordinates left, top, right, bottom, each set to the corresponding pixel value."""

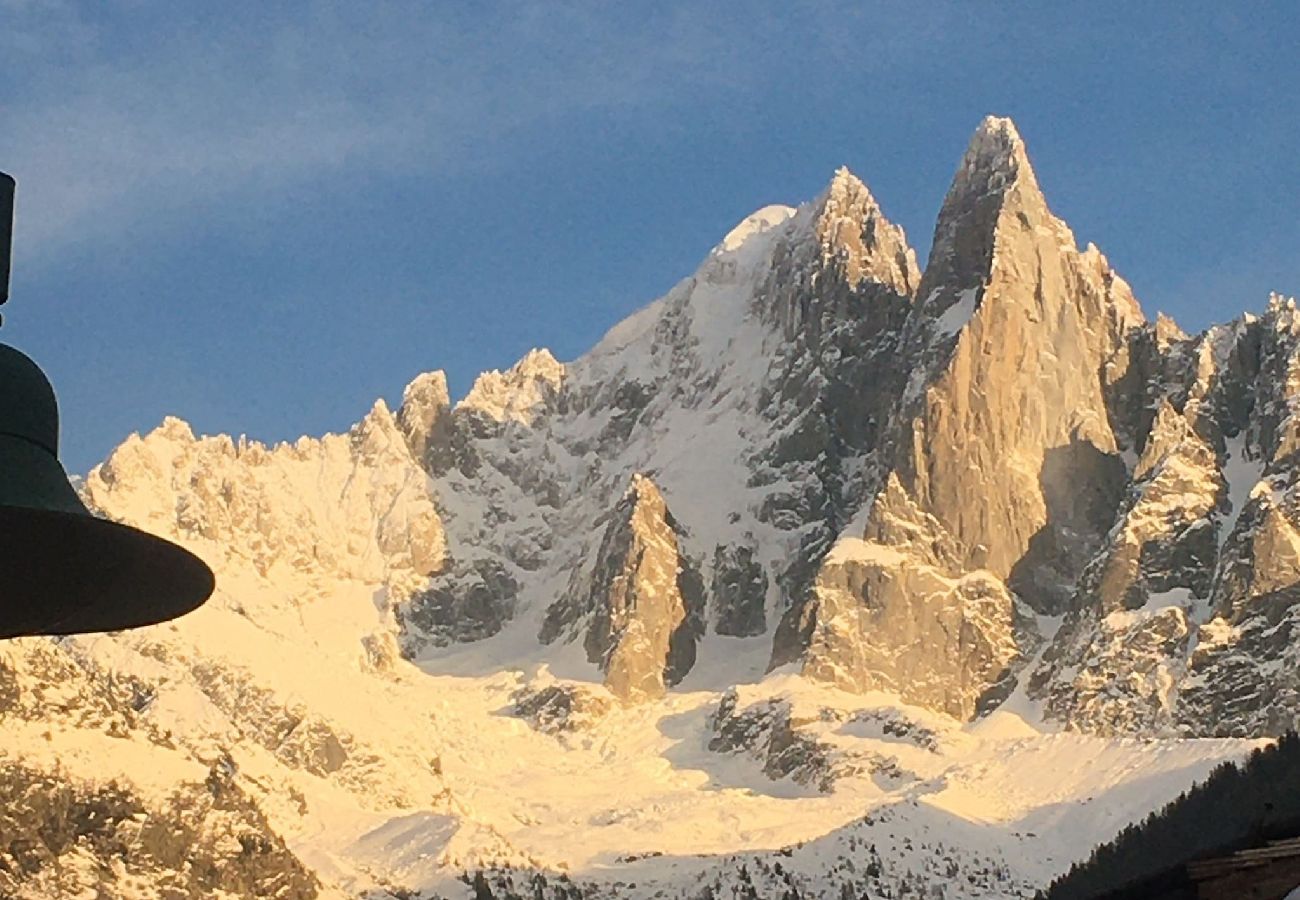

left=0, top=118, right=1300, bottom=897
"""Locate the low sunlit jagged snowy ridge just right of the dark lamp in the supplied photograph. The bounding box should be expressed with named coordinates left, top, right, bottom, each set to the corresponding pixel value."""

left=83, top=392, right=446, bottom=580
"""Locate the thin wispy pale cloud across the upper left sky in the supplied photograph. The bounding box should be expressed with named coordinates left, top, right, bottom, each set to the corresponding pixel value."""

left=0, top=0, right=935, bottom=264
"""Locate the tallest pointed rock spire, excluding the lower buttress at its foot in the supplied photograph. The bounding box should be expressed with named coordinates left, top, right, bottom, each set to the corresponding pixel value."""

left=883, top=117, right=1141, bottom=590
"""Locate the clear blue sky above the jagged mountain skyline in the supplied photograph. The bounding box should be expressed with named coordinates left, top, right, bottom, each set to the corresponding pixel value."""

left=0, top=0, right=1300, bottom=471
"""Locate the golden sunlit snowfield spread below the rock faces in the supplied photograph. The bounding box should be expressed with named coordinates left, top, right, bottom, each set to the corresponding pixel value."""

left=0, top=572, right=1255, bottom=897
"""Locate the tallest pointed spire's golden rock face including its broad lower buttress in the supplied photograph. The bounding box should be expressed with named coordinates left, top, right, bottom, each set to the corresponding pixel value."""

left=801, top=118, right=1141, bottom=718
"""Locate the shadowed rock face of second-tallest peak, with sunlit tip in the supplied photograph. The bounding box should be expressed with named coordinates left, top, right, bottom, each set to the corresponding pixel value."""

left=738, top=175, right=920, bottom=665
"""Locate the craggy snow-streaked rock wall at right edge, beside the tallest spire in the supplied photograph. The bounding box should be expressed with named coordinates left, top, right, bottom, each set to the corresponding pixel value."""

left=1030, top=297, right=1300, bottom=736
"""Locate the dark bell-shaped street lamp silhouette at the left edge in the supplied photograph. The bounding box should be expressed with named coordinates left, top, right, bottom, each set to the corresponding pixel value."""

left=0, top=172, right=216, bottom=637
